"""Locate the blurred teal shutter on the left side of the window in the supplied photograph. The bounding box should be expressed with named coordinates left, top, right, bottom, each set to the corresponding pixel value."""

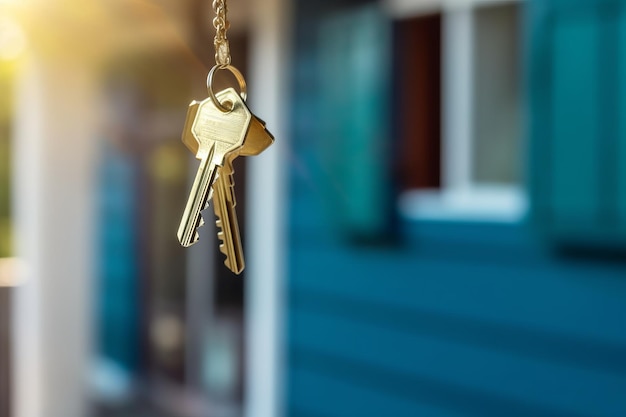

left=318, top=5, right=392, bottom=240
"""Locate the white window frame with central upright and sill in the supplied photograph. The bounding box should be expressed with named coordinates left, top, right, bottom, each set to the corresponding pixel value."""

left=386, top=0, right=528, bottom=222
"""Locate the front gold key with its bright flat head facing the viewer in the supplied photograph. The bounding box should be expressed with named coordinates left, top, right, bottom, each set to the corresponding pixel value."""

left=178, top=88, right=252, bottom=247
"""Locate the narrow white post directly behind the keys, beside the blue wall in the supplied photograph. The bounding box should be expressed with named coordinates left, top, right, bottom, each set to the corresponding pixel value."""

left=244, top=0, right=292, bottom=417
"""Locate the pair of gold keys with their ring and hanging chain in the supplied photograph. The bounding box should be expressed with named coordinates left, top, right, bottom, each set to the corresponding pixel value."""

left=178, top=0, right=274, bottom=274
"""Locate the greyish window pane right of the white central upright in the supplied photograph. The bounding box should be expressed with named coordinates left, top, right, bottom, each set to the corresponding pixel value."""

left=472, top=4, right=522, bottom=184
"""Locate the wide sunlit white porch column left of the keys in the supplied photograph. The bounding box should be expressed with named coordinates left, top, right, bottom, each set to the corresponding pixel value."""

left=12, top=58, right=96, bottom=417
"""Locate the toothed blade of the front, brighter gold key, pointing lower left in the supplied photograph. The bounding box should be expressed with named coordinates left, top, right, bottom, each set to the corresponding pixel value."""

left=177, top=145, right=217, bottom=248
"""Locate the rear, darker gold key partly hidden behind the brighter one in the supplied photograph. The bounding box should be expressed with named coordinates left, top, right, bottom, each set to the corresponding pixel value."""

left=213, top=116, right=274, bottom=274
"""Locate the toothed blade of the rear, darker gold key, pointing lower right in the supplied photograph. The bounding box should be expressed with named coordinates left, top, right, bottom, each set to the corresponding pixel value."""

left=213, top=161, right=245, bottom=275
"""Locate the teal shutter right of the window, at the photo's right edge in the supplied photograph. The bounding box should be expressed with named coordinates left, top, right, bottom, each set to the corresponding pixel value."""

left=529, top=0, right=626, bottom=244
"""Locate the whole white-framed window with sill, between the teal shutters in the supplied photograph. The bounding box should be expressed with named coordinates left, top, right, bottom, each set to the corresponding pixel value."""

left=392, top=0, right=526, bottom=221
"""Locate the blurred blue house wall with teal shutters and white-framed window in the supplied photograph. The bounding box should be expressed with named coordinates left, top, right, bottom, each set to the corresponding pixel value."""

left=286, top=0, right=626, bottom=417
